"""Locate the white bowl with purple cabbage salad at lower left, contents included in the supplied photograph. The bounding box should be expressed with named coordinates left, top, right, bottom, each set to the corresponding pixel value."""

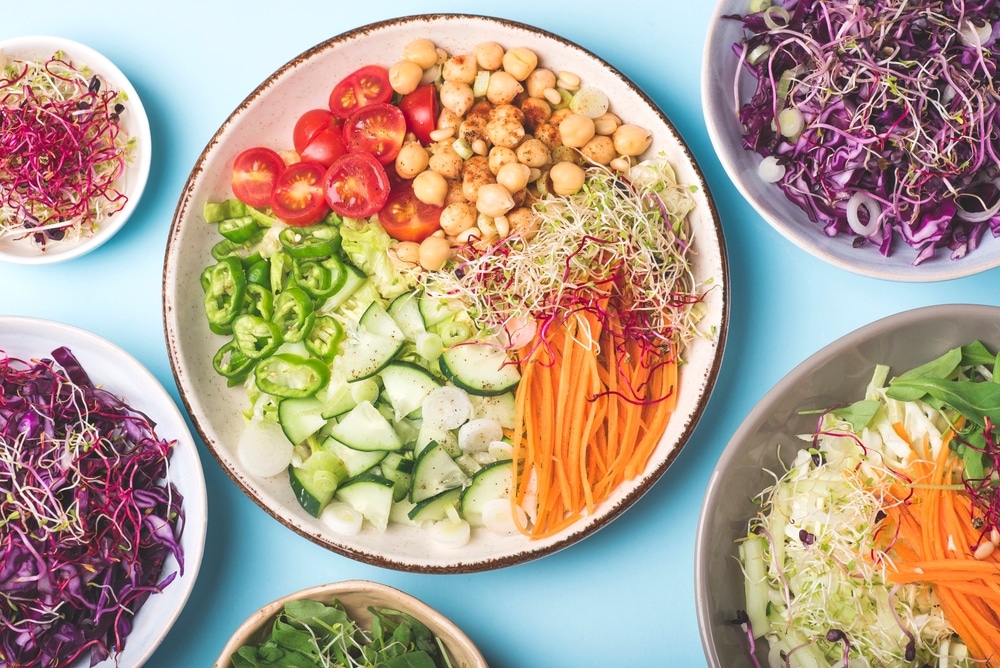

left=0, top=316, right=208, bottom=668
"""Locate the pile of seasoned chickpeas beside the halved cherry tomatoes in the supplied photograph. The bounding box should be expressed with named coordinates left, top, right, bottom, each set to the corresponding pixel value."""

left=389, top=39, right=652, bottom=271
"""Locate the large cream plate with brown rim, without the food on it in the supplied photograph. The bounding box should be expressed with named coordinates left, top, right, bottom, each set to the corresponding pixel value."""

left=163, top=15, right=728, bottom=572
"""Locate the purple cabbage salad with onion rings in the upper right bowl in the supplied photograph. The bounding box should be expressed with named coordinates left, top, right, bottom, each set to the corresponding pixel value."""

left=724, top=0, right=1000, bottom=265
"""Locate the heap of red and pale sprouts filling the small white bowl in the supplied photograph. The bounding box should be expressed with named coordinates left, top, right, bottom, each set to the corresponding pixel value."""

left=0, top=53, right=130, bottom=247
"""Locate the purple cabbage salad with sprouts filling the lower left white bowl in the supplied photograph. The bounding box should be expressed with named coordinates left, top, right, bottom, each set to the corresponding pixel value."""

left=0, top=347, right=184, bottom=668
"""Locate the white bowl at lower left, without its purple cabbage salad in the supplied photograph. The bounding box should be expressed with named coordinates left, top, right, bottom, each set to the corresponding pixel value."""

left=0, top=316, right=208, bottom=668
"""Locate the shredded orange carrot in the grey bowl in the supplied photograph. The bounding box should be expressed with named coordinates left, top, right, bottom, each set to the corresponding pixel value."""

left=886, top=425, right=1000, bottom=668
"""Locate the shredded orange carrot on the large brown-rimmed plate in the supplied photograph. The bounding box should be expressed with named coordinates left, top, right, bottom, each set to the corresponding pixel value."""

left=511, top=310, right=678, bottom=538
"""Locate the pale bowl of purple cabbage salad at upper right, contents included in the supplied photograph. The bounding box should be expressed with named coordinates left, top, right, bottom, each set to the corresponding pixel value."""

left=702, top=0, right=1000, bottom=282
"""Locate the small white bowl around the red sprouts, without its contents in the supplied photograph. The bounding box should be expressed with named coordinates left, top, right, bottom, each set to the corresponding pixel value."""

left=0, top=36, right=152, bottom=264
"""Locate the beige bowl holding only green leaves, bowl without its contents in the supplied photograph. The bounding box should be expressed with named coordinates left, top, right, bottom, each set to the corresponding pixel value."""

left=213, top=580, right=487, bottom=668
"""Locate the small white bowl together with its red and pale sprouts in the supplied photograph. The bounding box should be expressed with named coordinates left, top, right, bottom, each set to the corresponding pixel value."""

left=0, top=36, right=152, bottom=264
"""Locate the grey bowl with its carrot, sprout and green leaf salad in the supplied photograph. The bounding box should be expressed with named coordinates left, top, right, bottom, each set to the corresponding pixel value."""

left=695, top=304, right=1000, bottom=666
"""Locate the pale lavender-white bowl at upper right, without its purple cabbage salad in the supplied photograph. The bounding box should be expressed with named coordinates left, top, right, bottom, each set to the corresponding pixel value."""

left=701, top=0, right=1000, bottom=282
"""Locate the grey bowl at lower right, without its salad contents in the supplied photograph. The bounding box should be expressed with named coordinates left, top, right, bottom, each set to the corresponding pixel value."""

left=694, top=304, right=1000, bottom=668
